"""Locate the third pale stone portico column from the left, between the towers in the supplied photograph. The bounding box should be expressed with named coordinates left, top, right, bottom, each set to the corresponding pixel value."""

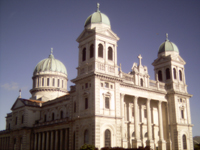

left=146, top=99, right=154, bottom=149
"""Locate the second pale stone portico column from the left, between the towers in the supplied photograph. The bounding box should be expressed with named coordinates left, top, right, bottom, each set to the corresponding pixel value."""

left=132, top=96, right=141, bottom=148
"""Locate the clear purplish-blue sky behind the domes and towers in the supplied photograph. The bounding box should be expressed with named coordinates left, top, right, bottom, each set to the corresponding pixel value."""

left=0, top=0, right=200, bottom=136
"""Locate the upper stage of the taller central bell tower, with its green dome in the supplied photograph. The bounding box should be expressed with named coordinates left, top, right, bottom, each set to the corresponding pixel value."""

left=77, top=4, right=119, bottom=77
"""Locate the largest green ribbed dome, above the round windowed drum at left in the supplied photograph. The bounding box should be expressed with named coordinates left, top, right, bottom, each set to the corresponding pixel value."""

left=33, top=52, right=67, bottom=75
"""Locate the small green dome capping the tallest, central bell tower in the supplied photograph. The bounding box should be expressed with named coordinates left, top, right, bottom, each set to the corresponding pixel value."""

left=85, top=3, right=110, bottom=27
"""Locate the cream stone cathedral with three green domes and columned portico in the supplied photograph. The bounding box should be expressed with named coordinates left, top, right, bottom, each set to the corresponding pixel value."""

left=0, top=4, right=193, bottom=150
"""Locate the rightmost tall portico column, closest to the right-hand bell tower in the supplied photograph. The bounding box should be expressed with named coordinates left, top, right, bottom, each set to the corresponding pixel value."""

left=158, top=101, right=166, bottom=150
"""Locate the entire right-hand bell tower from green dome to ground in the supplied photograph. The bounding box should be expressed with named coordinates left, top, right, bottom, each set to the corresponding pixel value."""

left=152, top=34, right=193, bottom=149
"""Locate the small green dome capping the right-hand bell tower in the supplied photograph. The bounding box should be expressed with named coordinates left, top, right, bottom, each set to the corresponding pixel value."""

left=158, top=34, right=179, bottom=54
